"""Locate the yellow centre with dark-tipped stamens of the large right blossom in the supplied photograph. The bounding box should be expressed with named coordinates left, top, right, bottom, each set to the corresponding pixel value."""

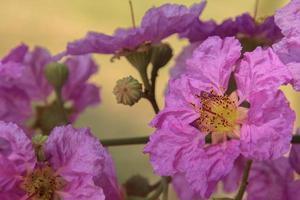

left=196, top=91, right=247, bottom=143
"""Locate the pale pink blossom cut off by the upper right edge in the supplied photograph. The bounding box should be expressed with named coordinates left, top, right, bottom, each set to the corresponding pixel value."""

left=273, top=0, right=300, bottom=91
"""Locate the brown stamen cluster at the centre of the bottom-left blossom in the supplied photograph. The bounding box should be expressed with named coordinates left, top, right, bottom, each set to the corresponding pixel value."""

left=21, top=166, right=65, bottom=200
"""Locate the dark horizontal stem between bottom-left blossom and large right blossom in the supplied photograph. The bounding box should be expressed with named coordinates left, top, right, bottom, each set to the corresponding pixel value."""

left=101, top=136, right=149, bottom=147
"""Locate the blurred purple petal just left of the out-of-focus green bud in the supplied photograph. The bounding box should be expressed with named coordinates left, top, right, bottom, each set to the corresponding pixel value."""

left=18, top=47, right=53, bottom=101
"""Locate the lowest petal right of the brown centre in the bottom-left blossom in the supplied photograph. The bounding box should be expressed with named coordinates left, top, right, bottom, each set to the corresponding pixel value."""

left=57, top=176, right=108, bottom=200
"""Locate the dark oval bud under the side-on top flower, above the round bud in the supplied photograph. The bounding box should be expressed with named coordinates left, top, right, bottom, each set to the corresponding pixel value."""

left=151, top=43, right=173, bottom=69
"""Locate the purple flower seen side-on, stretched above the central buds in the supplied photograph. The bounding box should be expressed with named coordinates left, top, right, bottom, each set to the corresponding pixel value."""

left=67, top=1, right=206, bottom=55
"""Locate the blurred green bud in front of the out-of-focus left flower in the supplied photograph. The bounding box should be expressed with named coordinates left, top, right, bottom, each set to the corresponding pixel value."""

left=45, top=62, right=69, bottom=89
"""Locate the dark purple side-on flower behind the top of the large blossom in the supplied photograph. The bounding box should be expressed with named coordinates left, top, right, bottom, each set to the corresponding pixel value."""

left=180, top=13, right=282, bottom=51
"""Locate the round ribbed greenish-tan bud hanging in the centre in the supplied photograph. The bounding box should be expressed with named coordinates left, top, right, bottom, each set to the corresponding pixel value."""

left=113, top=76, right=143, bottom=106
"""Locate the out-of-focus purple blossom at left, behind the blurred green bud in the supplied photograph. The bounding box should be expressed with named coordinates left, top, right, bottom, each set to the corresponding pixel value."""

left=0, top=44, right=100, bottom=123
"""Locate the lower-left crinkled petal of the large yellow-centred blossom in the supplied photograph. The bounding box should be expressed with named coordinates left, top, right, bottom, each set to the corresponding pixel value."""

left=144, top=117, right=204, bottom=176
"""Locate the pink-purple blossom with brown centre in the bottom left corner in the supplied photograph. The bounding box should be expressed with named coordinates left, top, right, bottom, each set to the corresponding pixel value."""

left=0, top=122, right=120, bottom=200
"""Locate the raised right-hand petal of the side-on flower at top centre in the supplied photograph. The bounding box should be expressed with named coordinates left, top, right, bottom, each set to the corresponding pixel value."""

left=141, top=1, right=206, bottom=42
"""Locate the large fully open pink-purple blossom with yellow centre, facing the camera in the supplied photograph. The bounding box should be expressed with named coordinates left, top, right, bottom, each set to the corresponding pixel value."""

left=144, top=37, right=295, bottom=197
